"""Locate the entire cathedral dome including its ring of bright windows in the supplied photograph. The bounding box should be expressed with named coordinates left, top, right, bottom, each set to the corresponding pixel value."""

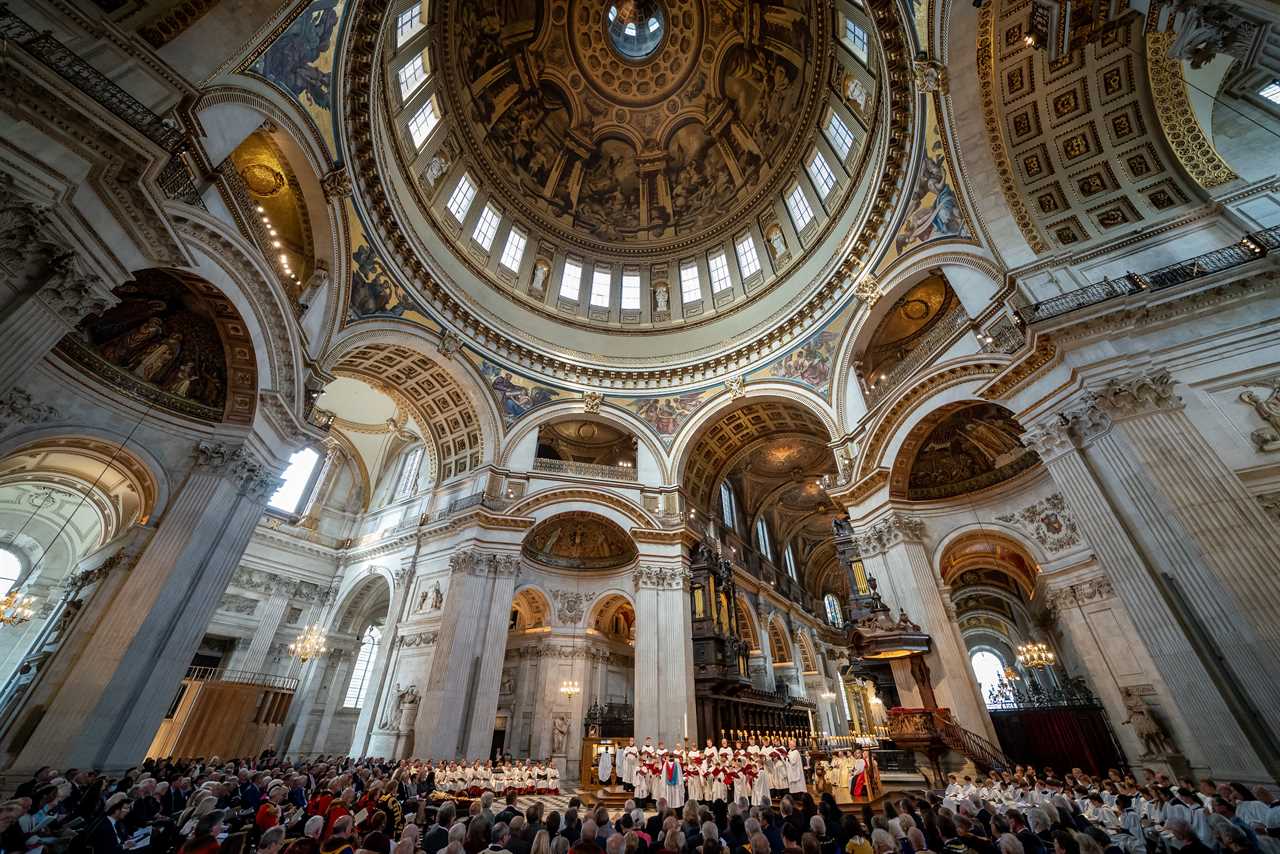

left=349, top=0, right=910, bottom=376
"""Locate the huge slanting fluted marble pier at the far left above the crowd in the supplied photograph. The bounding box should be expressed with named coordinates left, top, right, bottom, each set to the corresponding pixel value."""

left=5, top=442, right=279, bottom=773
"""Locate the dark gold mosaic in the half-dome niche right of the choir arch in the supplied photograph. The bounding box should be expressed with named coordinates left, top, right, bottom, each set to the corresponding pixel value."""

left=906, top=403, right=1039, bottom=501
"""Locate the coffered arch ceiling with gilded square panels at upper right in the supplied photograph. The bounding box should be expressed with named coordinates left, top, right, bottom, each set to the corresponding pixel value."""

left=978, top=6, right=1196, bottom=251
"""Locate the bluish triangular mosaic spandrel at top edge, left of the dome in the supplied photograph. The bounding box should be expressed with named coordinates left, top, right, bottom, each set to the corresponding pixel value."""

left=250, top=0, right=347, bottom=150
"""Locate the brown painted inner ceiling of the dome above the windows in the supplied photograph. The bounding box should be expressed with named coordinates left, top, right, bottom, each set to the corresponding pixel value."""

left=435, top=0, right=835, bottom=251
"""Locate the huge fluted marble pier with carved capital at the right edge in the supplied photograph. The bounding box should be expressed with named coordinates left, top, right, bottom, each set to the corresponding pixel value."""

left=1025, top=371, right=1280, bottom=780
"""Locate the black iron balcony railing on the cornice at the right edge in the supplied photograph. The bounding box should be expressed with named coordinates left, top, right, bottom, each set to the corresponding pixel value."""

left=1018, top=225, right=1280, bottom=324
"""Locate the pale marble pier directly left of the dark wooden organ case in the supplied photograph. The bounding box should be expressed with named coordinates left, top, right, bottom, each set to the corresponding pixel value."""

left=632, top=566, right=698, bottom=745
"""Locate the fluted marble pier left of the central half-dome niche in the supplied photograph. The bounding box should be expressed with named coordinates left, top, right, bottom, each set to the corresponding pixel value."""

left=417, top=549, right=520, bottom=759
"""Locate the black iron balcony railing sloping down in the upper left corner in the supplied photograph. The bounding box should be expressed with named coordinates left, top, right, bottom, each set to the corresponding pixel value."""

left=0, top=4, right=204, bottom=207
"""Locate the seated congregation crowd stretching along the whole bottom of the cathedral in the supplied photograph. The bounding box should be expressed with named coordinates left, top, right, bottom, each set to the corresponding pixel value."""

left=0, top=755, right=1280, bottom=854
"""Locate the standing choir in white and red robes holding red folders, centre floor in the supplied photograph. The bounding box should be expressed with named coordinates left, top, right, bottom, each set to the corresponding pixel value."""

left=596, top=739, right=839, bottom=808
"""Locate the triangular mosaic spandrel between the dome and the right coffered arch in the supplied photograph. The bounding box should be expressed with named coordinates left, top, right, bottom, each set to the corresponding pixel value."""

left=881, top=99, right=970, bottom=269
